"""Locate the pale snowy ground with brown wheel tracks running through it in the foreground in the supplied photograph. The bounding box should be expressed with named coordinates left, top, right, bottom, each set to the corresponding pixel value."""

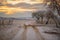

left=0, top=20, right=60, bottom=40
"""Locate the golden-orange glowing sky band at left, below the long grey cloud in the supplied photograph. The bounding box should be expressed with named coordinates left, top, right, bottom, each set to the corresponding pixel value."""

left=0, top=6, right=35, bottom=14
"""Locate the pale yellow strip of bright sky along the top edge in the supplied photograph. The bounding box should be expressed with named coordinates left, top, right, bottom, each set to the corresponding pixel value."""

left=7, top=0, right=44, bottom=5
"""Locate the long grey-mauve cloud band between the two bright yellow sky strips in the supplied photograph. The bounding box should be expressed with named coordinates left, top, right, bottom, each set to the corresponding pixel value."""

left=0, top=2, right=46, bottom=9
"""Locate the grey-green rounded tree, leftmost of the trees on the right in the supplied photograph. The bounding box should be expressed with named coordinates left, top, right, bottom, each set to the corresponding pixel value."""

left=32, top=11, right=44, bottom=23
